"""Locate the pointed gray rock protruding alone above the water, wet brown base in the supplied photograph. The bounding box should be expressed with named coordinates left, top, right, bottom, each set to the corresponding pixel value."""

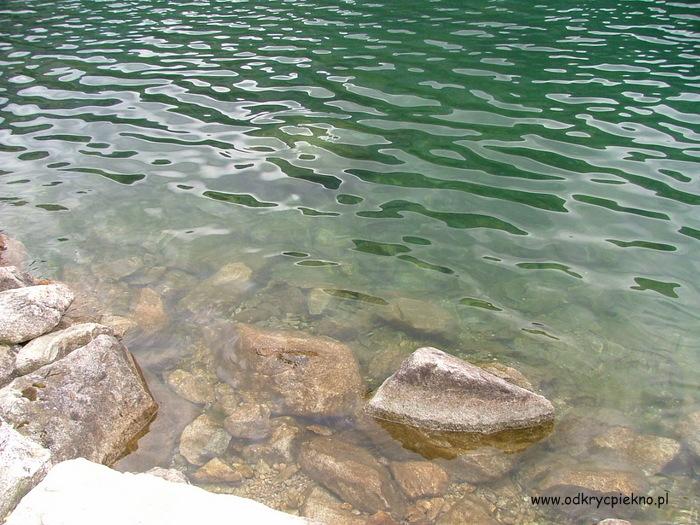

left=367, top=347, right=554, bottom=435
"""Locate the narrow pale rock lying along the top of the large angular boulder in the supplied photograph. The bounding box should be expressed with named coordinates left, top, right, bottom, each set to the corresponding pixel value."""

left=16, top=323, right=112, bottom=375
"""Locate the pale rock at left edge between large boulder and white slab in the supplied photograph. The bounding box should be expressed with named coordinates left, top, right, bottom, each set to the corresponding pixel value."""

left=0, top=418, right=51, bottom=521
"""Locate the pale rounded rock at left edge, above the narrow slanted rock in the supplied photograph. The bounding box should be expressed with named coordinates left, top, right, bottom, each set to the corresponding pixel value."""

left=0, top=284, right=74, bottom=344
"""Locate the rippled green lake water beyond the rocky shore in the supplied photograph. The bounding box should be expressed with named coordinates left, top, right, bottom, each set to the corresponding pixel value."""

left=0, top=1, right=700, bottom=523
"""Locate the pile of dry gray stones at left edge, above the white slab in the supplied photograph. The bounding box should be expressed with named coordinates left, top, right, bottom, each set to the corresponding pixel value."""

left=0, top=236, right=157, bottom=518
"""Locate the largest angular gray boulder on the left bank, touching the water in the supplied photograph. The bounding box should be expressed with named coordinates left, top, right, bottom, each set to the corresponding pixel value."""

left=0, top=335, right=157, bottom=464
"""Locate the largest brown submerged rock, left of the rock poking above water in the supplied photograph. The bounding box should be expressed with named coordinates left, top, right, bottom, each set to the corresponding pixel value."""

left=224, top=324, right=363, bottom=416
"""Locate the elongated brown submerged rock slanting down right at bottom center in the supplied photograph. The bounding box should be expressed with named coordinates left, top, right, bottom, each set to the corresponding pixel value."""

left=299, top=438, right=405, bottom=515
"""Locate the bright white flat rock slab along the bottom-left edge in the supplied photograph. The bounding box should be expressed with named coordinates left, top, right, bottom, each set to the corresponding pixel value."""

left=6, top=459, right=308, bottom=525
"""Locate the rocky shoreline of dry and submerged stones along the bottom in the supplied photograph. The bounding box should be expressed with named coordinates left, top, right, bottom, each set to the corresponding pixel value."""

left=0, top=234, right=700, bottom=525
